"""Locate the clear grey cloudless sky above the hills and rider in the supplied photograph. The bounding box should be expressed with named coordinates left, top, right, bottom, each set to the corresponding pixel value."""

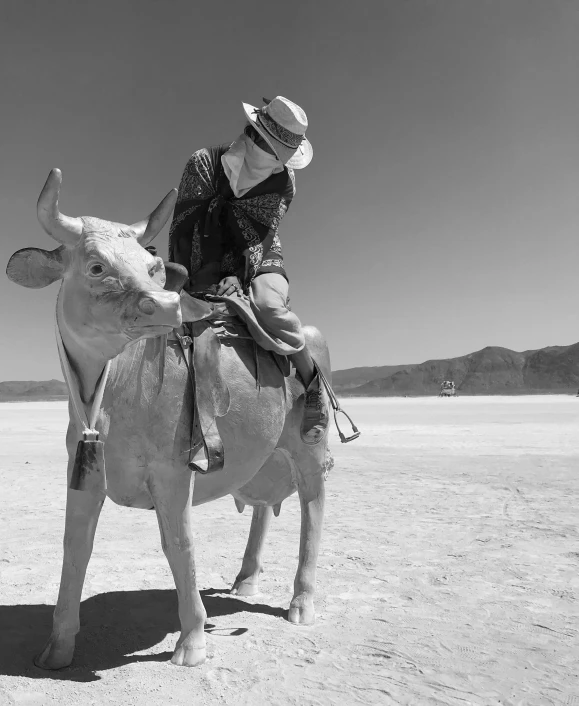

left=0, top=0, right=579, bottom=380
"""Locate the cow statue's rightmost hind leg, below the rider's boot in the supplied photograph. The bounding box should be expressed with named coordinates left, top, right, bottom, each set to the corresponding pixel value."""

left=288, top=448, right=326, bottom=625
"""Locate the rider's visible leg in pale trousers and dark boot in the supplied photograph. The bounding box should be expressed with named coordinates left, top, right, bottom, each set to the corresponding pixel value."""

left=251, top=272, right=329, bottom=444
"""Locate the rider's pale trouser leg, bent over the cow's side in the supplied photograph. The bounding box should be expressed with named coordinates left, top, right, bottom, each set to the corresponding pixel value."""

left=249, top=272, right=306, bottom=351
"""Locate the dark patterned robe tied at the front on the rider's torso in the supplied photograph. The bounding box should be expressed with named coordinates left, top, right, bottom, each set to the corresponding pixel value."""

left=169, top=144, right=295, bottom=291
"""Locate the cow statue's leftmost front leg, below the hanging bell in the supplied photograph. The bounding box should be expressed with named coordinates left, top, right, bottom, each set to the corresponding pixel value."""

left=34, top=490, right=105, bottom=669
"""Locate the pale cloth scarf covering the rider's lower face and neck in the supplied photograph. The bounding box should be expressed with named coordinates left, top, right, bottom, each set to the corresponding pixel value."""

left=221, top=133, right=283, bottom=198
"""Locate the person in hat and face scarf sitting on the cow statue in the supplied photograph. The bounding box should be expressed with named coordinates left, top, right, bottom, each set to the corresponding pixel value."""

left=169, top=96, right=329, bottom=444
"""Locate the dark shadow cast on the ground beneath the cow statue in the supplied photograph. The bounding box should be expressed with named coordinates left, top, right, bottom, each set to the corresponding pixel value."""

left=0, top=588, right=287, bottom=682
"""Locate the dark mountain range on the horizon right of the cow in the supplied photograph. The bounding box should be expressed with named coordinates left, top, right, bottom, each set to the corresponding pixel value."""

left=332, top=343, right=579, bottom=397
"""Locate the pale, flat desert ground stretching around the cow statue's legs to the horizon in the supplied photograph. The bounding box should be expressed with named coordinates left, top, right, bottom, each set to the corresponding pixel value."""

left=0, top=396, right=579, bottom=706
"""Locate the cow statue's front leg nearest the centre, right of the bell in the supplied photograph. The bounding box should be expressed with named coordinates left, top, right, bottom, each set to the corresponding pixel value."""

left=151, top=471, right=207, bottom=667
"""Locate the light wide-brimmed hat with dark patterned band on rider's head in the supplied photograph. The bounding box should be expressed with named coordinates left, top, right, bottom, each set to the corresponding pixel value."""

left=242, top=96, right=314, bottom=169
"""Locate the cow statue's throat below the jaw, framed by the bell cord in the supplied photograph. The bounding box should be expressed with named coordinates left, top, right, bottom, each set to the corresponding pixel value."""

left=56, top=296, right=127, bottom=406
